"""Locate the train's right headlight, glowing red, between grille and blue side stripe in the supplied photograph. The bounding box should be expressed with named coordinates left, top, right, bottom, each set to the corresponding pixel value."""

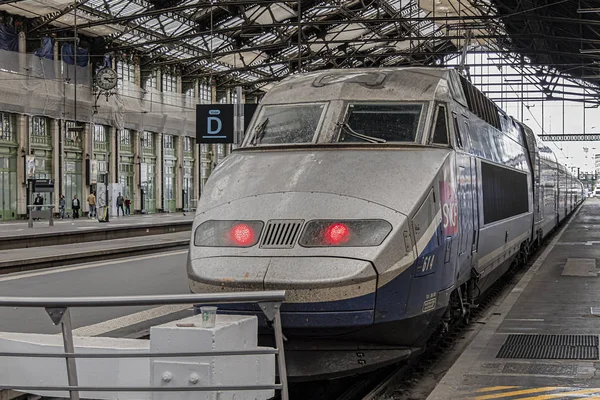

left=300, top=219, right=392, bottom=247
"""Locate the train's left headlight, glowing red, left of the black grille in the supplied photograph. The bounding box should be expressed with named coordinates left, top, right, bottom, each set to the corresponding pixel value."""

left=194, top=220, right=263, bottom=247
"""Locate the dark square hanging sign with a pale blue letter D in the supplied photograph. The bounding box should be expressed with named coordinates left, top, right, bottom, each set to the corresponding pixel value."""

left=196, top=104, right=235, bottom=144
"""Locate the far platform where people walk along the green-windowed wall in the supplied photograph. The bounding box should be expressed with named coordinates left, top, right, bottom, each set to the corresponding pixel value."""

left=0, top=213, right=194, bottom=250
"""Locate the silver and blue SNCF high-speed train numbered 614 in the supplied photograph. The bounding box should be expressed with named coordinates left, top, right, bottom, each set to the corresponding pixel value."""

left=187, top=67, right=585, bottom=379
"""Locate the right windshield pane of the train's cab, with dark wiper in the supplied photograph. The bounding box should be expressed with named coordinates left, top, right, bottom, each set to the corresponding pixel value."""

left=338, top=104, right=423, bottom=143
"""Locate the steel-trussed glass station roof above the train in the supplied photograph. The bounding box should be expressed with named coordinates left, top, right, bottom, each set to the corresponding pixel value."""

left=0, top=0, right=600, bottom=96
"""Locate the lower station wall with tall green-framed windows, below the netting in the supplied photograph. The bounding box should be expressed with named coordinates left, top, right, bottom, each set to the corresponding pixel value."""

left=0, top=111, right=200, bottom=220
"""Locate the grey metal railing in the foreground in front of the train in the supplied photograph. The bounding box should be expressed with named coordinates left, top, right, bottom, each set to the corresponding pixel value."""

left=0, top=290, right=289, bottom=400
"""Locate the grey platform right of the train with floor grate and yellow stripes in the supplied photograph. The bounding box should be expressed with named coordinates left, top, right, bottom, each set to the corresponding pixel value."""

left=427, top=198, right=600, bottom=400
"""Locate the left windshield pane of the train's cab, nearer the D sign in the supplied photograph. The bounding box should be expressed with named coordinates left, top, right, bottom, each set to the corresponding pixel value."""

left=248, top=104, right=325, bottom=146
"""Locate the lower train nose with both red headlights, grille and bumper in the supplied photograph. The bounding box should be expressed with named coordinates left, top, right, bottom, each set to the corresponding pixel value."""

left=188, top=192, right=407, bottom=332
